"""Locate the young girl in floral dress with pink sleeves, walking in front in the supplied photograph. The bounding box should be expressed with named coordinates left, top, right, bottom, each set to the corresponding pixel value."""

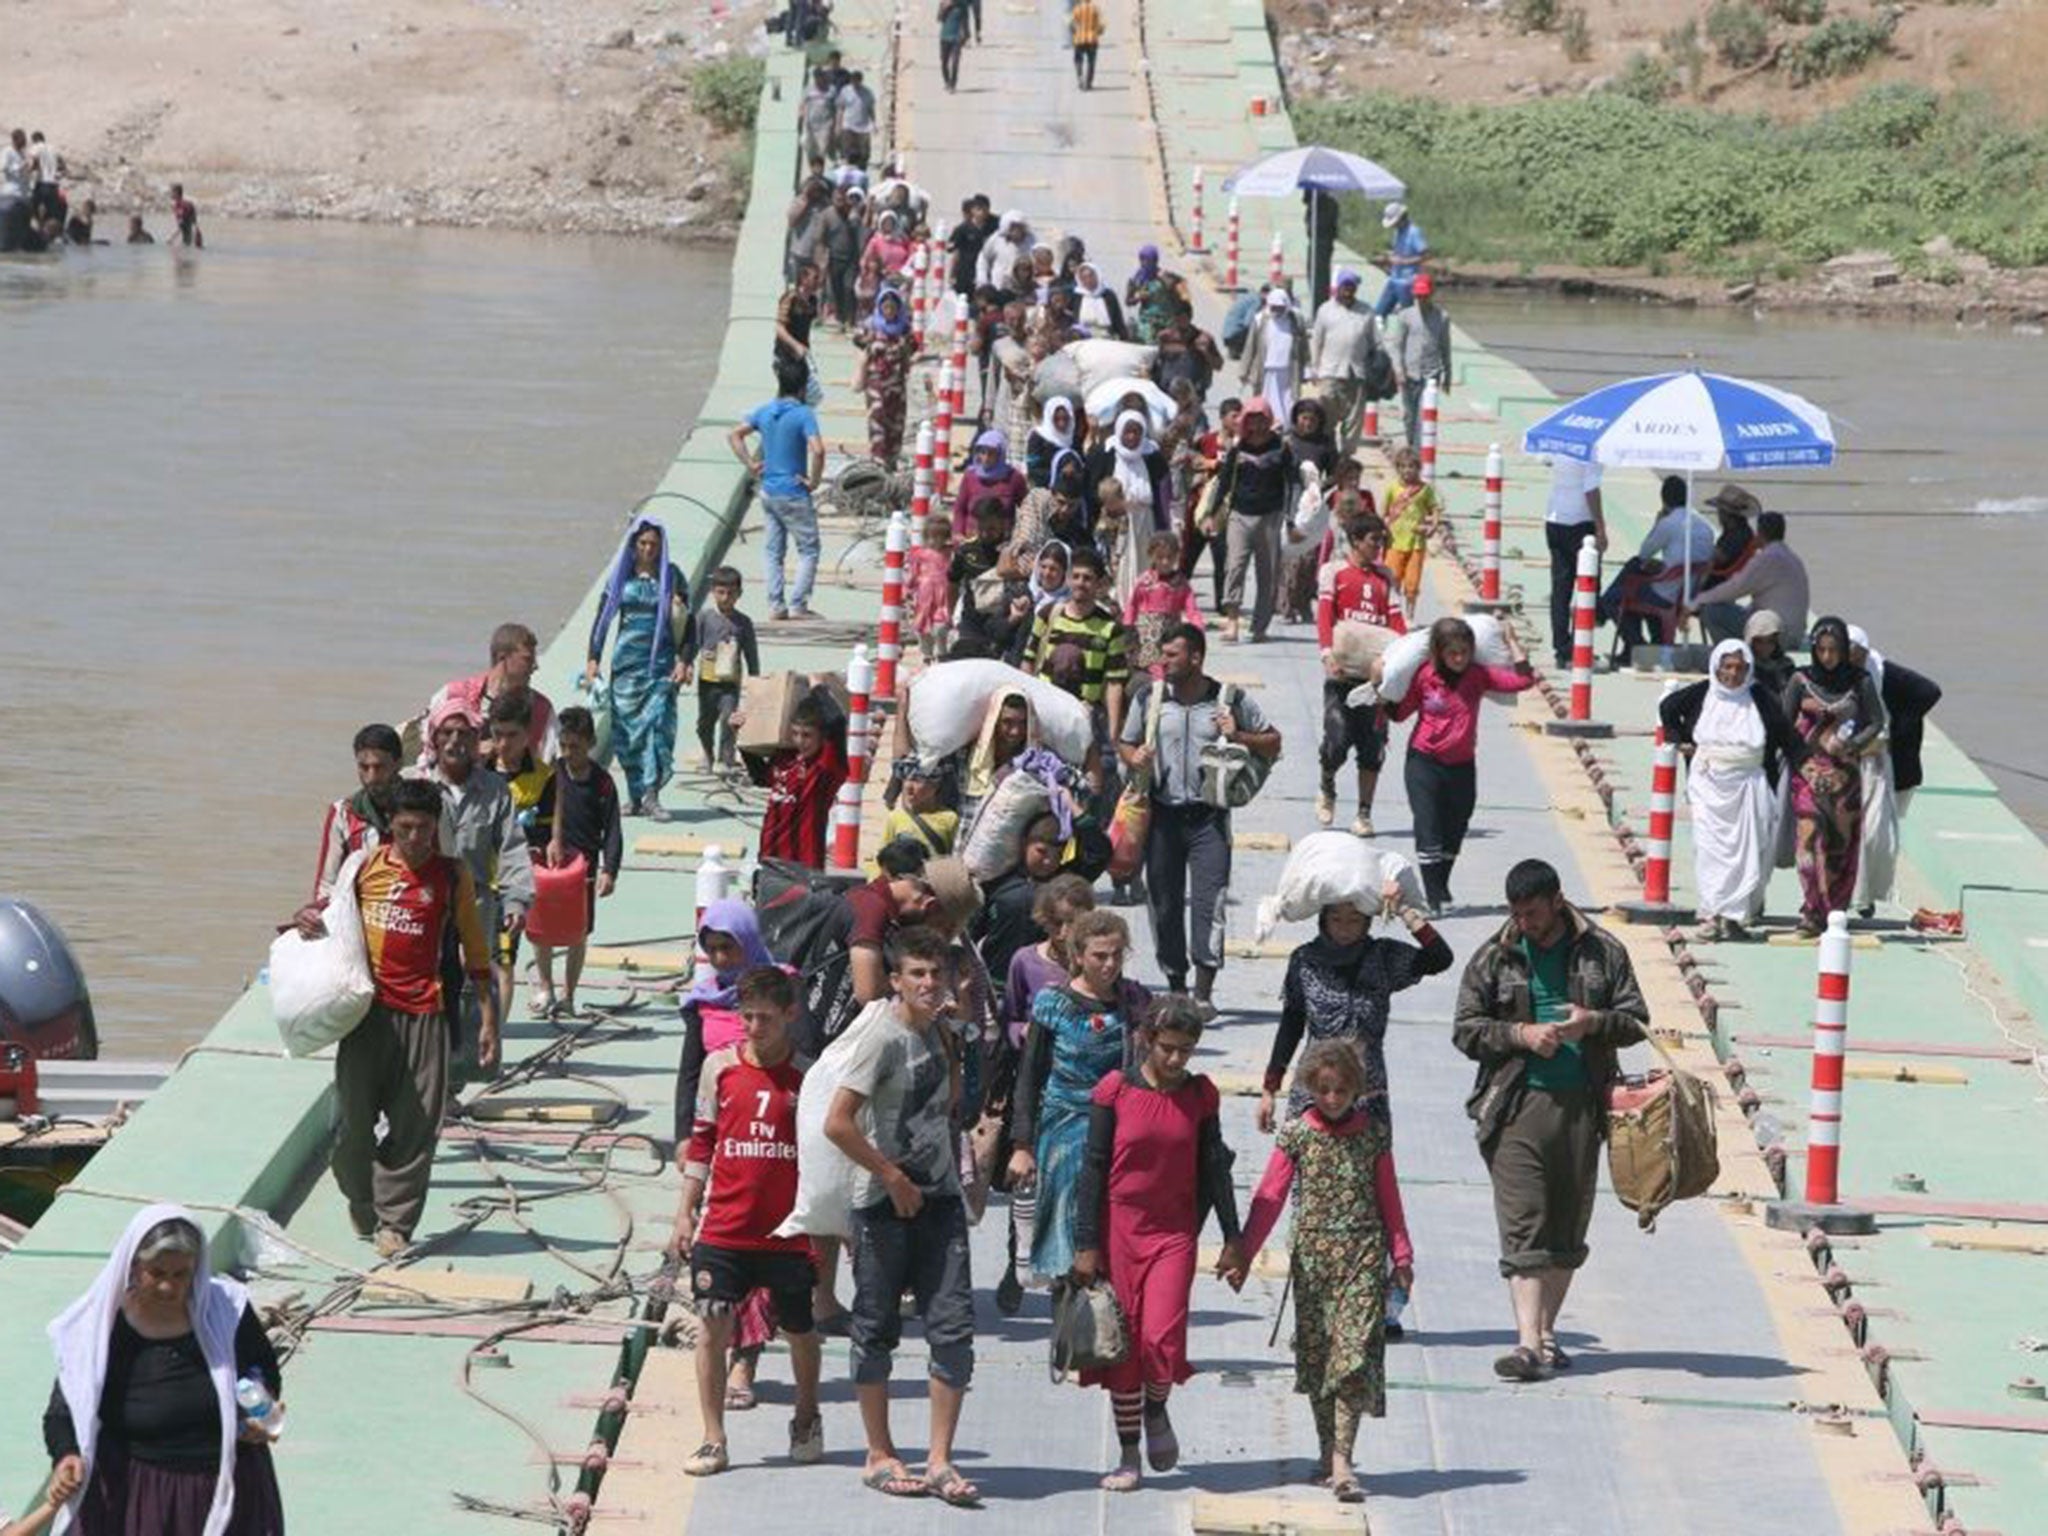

left=1225, top=1040, right=1415, bottom=1503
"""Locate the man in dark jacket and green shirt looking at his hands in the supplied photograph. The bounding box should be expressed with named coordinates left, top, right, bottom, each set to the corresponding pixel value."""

left=1452, top=858, right=1649, bottom=1382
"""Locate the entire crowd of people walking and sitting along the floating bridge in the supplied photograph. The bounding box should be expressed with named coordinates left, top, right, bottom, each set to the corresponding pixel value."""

left=8, top=27, right=1939, bottom=1536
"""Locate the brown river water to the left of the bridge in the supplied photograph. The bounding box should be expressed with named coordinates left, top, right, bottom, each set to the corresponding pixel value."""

left=0, top=223, right=729, bottom=1055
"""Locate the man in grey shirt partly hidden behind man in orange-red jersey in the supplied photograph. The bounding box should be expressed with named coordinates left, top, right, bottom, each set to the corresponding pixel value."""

left=406, top=696, right=532, bottom=1061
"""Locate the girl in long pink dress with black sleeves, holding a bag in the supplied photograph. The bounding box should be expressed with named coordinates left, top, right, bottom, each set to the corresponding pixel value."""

left=1073, top=997, right=1243, bottom=1493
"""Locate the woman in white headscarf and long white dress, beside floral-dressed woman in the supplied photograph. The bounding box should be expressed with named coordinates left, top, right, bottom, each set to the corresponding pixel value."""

left=1657, top=639, right=1800, bottom=942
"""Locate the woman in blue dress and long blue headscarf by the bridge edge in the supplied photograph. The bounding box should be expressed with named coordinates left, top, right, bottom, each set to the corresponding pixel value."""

left=584, top=518, right=696, bottom=821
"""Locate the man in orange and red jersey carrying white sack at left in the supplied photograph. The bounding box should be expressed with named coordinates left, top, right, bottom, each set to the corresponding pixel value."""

left=315, top=778, right=498, bottom=1257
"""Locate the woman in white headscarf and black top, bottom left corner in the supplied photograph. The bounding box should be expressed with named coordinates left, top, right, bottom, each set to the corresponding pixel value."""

left=43, top=1204, right=285, bottom=1536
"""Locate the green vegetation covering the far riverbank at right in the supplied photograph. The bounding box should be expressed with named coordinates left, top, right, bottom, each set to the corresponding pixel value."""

left=1292, top=83, right=2048, bottom=281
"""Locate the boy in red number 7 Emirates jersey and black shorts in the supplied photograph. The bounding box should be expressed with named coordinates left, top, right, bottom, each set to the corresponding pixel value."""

left=670, top=965, right=825, bottom=1477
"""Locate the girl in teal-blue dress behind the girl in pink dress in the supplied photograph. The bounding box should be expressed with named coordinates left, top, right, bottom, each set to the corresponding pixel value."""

left=1010, top=911, right=1151, bottom=1282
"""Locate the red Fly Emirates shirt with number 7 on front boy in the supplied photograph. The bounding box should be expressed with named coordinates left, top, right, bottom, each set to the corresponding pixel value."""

left=684, top=1044, right=811, bottom=1253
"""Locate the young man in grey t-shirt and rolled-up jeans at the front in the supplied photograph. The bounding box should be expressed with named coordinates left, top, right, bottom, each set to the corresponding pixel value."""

left=825, top=928, right=981, bottom=1505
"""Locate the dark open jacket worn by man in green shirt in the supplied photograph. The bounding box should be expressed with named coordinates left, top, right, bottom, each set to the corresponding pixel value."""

left=1450, top=907, right=1651, bottom=1147
